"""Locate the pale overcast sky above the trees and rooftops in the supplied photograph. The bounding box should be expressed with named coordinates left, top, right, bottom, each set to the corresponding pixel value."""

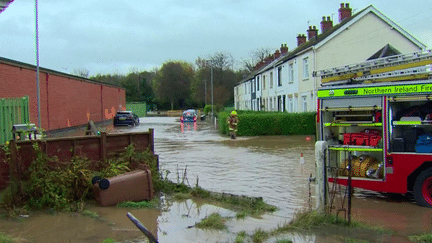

left=0, top=0, right=432, bottom=76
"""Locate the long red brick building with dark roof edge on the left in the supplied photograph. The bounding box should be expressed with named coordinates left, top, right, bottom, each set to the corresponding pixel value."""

left=0, top=57, right=126, bottom=131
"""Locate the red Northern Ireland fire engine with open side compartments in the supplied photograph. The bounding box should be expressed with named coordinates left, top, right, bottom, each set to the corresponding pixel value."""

left=314, top=50, right=432, bottom=207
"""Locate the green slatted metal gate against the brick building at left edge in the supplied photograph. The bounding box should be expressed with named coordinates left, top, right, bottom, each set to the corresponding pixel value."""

left=0, top=96, right=30, bottom=144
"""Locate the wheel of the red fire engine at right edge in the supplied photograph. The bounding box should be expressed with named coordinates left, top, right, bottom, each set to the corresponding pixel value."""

left=414, top=168, right=432, bottom=208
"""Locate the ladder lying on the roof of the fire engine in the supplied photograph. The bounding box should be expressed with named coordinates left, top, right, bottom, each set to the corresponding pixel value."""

left=313, top=50, right=432, bottom=85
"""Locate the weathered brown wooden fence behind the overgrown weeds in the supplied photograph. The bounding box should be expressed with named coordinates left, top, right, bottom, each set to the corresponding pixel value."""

left=0, top=129, right=154, bottom=190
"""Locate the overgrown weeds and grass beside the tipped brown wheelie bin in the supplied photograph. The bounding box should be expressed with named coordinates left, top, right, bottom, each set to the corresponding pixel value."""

left=0, top=143, right=162, bottom=215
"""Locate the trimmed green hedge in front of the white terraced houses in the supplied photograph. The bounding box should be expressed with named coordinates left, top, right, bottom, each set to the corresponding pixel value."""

left=218, top=111, right=316, bottom=136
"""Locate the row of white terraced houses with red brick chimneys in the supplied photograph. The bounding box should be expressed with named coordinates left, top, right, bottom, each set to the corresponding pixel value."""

left=234, top=3, right=426, bottom=112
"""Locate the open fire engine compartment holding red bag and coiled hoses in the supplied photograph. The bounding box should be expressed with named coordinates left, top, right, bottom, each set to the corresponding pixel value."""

left=319, top=96, right=385, bottom=181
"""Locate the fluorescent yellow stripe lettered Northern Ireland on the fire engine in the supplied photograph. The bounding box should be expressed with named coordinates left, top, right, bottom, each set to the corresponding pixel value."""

left=318, top=83, right=432, bottom=98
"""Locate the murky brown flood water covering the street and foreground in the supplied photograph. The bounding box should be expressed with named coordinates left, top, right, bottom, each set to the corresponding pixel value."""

left=0, top=117, right=432, bottom=242
